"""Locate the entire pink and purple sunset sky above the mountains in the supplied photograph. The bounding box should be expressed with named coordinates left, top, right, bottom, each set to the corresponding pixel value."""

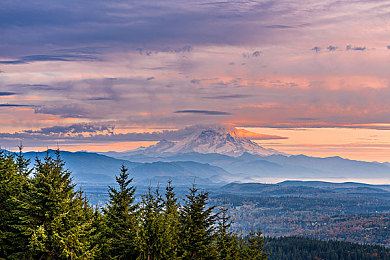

left=0, top=0, right=390, bottom=162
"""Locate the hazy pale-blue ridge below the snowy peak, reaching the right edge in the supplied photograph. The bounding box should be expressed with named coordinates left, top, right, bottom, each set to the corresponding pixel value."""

left=118, top=152, right=390, bottom=182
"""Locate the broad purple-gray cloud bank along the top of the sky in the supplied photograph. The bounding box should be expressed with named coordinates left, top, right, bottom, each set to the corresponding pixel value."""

left=0, top=0, right=386, bottom=60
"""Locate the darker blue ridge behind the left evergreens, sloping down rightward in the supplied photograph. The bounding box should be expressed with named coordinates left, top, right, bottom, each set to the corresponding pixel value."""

left=19, top=150, right=231, bottom=185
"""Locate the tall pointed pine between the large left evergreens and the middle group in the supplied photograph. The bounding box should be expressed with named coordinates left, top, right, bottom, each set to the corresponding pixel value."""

left=103, top=165, right=139, bottom=259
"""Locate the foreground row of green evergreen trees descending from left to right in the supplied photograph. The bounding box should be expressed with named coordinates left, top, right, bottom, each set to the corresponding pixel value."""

left=0, top=151, right=269, bottom=259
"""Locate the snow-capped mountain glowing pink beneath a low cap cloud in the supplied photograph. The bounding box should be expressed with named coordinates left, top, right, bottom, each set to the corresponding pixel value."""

left=133, top=126, right=282, bottom=157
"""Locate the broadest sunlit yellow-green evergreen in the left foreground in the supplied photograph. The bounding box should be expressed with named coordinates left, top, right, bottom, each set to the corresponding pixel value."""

left=19, top=151, right=95, bottom=259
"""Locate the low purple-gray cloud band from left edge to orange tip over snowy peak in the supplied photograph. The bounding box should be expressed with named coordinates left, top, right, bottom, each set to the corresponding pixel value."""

left=0, top=123, right=286, bottom=147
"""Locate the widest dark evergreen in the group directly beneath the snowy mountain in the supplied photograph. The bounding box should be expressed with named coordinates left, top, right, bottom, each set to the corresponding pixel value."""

left=179, top=184, right=217, bottom=259
